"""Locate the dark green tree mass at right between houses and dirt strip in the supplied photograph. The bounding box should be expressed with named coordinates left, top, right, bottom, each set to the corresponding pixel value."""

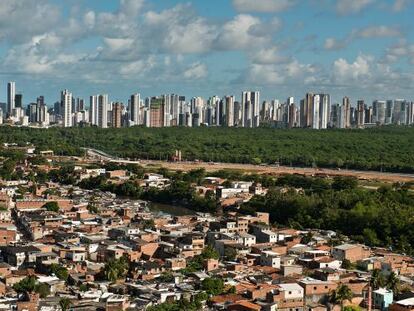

left=241, top=175, right=414, bottom=254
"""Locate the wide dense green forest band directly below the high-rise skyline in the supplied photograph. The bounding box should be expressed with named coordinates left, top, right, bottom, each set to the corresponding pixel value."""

left=0, top=126, right=414, bottom=173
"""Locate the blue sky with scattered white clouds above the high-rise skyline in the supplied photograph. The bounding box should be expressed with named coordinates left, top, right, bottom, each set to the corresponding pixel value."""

left=0, top=0, right=414, bottom=105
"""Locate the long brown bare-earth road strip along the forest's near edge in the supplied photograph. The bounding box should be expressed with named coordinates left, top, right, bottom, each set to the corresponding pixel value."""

left=83, top=149, right=414, bottom=183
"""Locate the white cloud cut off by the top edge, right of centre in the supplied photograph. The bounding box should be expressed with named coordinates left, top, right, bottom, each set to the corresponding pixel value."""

left=233, top=0, right=296, bottom=13
